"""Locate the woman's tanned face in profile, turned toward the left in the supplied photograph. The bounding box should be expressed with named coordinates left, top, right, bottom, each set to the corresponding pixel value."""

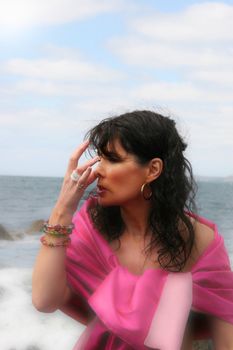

left=95, top=140, right=148, bottom=206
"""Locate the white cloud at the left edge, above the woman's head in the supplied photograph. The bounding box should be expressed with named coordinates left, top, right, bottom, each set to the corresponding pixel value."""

left=0, top=45, right=125, bottom=99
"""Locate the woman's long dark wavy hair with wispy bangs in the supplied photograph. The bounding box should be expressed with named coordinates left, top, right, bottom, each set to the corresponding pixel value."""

left=86, top=110, right=197, bottom=272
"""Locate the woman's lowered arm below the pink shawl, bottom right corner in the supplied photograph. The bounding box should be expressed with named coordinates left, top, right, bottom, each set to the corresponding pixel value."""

left=212, top=317, right=233, bottom=350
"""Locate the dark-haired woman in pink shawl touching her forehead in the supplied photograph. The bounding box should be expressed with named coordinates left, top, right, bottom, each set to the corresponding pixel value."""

left=32, top=111, right=233, bottom=350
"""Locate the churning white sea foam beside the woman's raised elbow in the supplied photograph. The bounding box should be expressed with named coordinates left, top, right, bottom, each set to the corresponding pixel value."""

left=0, top=268, right=85, bottom=350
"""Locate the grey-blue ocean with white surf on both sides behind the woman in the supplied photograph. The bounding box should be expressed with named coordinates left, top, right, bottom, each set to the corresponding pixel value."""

left=0, top=176, right=233, bottom=350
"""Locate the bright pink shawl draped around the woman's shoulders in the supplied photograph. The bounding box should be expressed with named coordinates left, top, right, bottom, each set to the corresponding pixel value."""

left=61, top=198, right=233, bottom=350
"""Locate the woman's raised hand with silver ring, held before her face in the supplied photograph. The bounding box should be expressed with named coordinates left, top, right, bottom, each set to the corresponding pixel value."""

left=55, top=140, right=99, bottom=215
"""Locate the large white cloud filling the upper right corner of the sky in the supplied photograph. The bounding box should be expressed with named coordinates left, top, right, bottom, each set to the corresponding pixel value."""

left=109, top=2, right=233, bottom=72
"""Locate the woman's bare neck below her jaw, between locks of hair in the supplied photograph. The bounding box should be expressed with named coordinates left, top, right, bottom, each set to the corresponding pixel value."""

left=121, top=199, right=151, bottom=240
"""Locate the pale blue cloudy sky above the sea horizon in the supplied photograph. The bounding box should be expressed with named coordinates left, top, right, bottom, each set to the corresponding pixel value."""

left=0, top=0, right=233, bottom=177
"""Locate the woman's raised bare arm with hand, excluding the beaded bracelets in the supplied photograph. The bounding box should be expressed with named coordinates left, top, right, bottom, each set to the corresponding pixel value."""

left=32, top=142, right=98, bottom=312
